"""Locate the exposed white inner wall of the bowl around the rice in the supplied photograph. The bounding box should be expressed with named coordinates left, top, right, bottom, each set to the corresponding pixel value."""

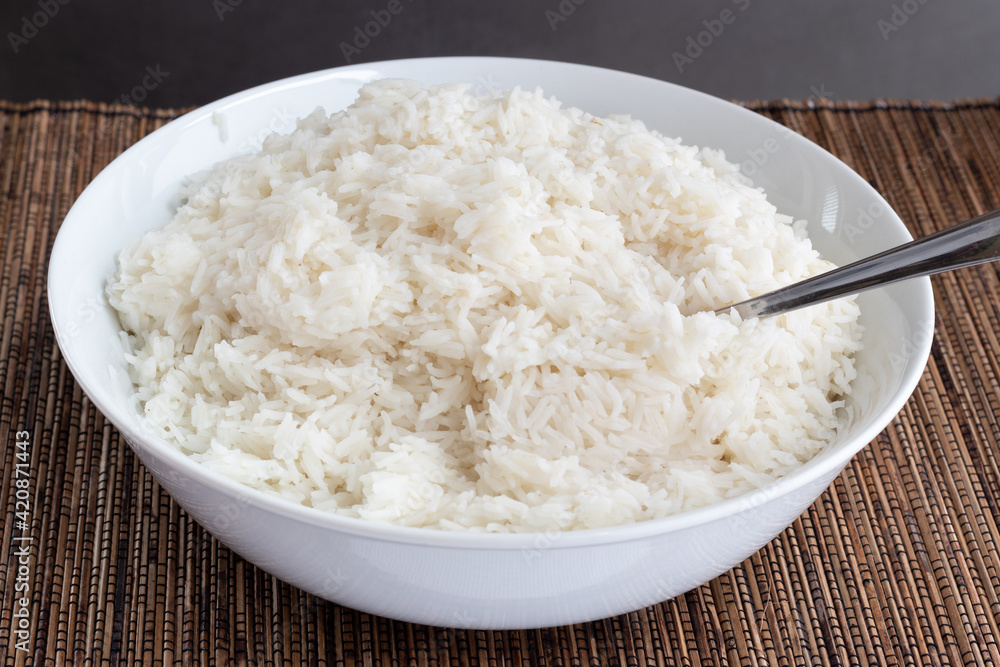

left=48, top=58, right=933, bottom=539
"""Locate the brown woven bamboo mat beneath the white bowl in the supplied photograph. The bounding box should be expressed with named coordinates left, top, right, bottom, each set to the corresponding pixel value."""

left=0, top=96, right=1000, bottom=665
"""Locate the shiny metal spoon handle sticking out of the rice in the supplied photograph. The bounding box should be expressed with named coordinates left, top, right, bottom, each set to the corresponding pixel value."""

left=715, top=209, right=1000, bottom=319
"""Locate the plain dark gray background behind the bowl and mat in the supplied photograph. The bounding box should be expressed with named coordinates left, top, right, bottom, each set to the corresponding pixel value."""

left=0, top=0, right=1000, bottom=106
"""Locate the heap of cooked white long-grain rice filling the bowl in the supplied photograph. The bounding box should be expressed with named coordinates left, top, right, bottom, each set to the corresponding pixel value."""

left=108, top=80, right=860, bottom=531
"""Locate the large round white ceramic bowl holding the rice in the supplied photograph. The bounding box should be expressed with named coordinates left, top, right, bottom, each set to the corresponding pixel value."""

left=48, top=58, right=933, bottom=628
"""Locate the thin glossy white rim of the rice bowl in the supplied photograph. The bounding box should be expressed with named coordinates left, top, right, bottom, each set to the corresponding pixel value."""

left=46, top=56, right=934, bottom=550
